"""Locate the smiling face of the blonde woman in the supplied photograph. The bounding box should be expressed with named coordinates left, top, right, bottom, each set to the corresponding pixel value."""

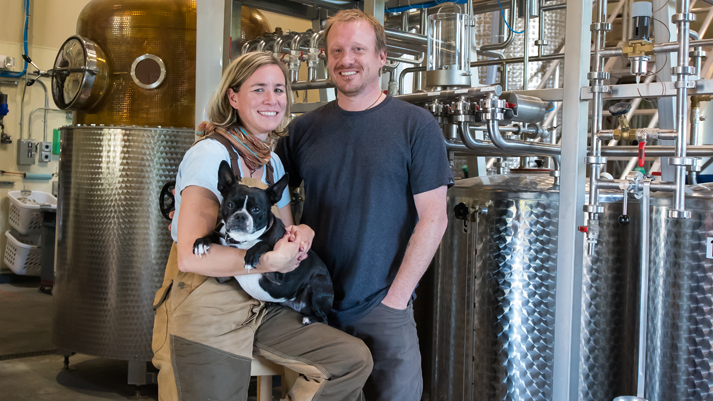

left=228, top=64, right=287, bottom=139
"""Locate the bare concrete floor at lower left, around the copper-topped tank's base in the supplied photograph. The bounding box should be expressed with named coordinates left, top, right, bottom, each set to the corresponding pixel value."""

left=0, top=273, right=272, bottom=401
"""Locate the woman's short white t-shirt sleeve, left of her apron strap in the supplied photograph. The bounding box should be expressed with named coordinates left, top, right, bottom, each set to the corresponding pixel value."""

left=176, top=139, right=229, bottom=201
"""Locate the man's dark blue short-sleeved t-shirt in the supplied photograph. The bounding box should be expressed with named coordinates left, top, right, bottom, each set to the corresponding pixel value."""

left=276, top=97, right=453, bottom=323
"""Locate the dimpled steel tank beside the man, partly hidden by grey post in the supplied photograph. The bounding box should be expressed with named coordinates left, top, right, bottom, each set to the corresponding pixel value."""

left=416, top=174, right=640, bottom=401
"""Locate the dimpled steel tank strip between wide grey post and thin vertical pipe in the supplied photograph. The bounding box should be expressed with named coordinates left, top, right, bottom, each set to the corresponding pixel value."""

left=579, top=198, right=641, bottom=401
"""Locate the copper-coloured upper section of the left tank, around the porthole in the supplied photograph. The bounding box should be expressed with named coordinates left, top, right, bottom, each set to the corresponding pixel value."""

left=74, top=0, right=196, bottom=127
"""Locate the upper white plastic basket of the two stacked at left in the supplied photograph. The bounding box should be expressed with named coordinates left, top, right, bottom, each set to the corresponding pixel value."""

left=7, top=191, right=57, bottom=234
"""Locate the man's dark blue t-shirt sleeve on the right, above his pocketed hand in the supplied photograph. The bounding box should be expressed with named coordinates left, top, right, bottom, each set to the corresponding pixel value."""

left=409, top=120, right=454, bottom=195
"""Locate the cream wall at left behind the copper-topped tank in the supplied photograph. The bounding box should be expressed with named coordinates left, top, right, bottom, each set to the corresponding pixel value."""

left=0, top=0, right=311, bottom=269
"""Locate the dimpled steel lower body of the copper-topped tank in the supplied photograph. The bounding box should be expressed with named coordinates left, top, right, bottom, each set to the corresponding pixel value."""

left=53, top=126, right=194, bottom=361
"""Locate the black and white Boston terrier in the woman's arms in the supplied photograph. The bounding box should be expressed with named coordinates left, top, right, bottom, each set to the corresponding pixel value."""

left=193, top=161, right=334, bottom=325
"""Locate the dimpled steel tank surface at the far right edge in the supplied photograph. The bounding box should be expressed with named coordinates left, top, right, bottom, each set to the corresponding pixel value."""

left=646, top=184, right=713, bottom=401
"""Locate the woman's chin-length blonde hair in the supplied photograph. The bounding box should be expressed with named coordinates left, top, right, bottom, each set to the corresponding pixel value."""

left=208, top=52, right=292, bottom=138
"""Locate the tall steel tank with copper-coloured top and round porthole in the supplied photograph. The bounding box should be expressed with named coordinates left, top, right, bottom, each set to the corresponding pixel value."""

left=53, top=0, right=196, bottom=372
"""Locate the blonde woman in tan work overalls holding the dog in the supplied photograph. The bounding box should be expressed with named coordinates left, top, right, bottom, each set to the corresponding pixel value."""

left=153, top=53, right=372, bottom=401
